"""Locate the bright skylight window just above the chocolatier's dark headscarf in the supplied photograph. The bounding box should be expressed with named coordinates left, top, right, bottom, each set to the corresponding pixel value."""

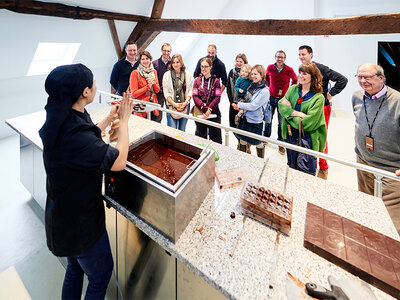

left=26, top=43, right=81, bottom=76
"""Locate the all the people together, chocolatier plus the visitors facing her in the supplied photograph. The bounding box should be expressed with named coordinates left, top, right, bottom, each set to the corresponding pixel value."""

left=35, top=38, right=400, bottom=299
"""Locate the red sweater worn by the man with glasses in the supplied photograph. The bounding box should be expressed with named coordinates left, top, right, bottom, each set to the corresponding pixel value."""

left=265, top=64, right=297, bottom=98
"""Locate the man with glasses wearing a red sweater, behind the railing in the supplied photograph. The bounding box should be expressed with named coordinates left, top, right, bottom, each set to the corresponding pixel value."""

left=264, top=50, right=297, bottom=155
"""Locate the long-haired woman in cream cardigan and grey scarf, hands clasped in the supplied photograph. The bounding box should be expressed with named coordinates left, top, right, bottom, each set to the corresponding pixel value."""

left=163, top=54, right=193, bottom=131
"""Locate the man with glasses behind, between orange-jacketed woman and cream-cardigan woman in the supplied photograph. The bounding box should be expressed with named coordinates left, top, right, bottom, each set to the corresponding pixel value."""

left=151, top=43, right=172, bottom=123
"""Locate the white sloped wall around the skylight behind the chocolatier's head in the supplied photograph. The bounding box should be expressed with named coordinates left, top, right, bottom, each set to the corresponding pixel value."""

left=0, top=10, right=117, bottom=138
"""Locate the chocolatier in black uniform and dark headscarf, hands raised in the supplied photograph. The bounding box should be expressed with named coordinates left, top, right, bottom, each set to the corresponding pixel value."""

left=39, top=64, right=133, bottom=299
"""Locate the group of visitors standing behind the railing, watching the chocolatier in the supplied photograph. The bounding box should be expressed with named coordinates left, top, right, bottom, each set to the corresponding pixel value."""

left=110, top=42, right=400, bottom=229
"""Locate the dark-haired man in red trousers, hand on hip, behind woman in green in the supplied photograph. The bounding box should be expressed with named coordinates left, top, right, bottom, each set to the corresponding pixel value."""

left=299, top=45, right=347, bottom=179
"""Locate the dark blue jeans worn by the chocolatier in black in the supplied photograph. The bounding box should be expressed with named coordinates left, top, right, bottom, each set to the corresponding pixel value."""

left=61, top=231, right=114, bottom=300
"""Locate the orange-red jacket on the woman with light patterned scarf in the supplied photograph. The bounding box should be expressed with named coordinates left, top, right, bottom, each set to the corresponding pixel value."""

left=129, top=70, right=160, bottom=118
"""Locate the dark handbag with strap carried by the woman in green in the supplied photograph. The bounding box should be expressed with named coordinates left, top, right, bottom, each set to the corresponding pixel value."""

left=287, top=118, right=317, bottom=175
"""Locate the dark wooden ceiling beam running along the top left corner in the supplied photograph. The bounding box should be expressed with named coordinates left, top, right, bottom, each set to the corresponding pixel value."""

left=0, top=0, right=149, bottom=22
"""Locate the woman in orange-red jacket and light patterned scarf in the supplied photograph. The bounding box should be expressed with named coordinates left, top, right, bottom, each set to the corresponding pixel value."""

left=129, top=51, right=160, bottom=121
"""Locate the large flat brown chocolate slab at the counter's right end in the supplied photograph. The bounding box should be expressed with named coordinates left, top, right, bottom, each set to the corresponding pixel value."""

left=304, top=203, right=400, bottom=299
